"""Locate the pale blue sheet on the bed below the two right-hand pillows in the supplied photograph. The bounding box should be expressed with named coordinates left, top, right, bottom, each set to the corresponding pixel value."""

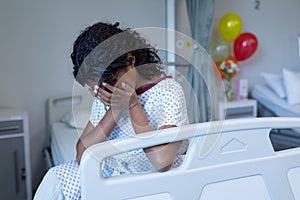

left=252, top=85, right=300, bottom=117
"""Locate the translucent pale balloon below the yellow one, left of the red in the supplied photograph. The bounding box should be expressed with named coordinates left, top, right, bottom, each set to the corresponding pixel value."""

left=208, top=38, right=230, bottom=62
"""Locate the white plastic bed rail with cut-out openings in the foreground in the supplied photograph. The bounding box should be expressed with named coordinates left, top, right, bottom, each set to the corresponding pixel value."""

left=80, top=117, right=300, bottom=200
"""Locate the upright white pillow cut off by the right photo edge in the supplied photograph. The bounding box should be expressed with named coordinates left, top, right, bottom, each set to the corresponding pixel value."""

left=282, top=69, right=300, bottom=104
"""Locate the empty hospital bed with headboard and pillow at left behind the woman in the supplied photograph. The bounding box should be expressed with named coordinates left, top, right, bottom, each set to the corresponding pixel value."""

left=44, top=91, right=93, bottom=169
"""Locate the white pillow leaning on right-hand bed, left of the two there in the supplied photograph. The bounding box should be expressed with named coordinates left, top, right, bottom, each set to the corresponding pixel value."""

left=260, top=73, right=286, bottom=99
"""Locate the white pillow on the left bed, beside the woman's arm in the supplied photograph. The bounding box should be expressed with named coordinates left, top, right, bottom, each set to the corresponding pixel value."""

left=61, top=109, right=90, bottom=129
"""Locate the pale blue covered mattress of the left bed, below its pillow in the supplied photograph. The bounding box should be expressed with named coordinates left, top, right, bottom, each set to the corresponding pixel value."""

left=51, top=122, right=80, bottom=165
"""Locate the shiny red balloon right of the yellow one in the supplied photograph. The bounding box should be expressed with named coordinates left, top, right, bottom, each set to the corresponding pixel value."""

left=233, top=33, right=258, bottom=61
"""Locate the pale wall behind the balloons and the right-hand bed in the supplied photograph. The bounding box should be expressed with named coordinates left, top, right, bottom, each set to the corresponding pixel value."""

left=176, top=0, right=300, bottom=90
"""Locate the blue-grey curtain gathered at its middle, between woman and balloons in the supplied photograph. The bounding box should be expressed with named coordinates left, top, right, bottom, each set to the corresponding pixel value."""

left=186, top=0, right=221, bottom=123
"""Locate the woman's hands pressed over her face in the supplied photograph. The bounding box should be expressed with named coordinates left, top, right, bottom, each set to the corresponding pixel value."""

left=94, top=82, right=138, bottom=110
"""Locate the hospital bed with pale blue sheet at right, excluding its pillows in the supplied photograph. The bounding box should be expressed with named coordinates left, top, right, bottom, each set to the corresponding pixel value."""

left=252, top=84, right=300, bottom=148
